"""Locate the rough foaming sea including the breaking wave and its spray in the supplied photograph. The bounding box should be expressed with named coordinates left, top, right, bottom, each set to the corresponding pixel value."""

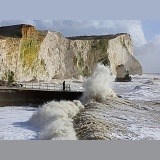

left=0, top=64, right=160, bottom=140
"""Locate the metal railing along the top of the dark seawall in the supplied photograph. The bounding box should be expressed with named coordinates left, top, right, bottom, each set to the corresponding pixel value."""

left=16, top=82, right=71, bottom=91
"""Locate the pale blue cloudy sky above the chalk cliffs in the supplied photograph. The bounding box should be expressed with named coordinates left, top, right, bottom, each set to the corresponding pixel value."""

left=0, top=20, right=160, bottom=73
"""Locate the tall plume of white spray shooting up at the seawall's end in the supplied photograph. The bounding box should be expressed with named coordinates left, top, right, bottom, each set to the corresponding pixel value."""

left=81, top=64, right=116, bottom=104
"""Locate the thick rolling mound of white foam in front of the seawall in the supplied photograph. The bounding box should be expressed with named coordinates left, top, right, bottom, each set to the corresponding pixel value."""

left=30, top=101, right=84, bottom=140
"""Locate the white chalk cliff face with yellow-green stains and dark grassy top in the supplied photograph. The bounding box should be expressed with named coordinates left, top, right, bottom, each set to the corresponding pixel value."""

left=0, top=25, right=142, bottom=81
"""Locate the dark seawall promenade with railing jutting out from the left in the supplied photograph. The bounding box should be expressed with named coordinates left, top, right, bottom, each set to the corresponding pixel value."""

left=0, top=82, right=83, bottom=107
